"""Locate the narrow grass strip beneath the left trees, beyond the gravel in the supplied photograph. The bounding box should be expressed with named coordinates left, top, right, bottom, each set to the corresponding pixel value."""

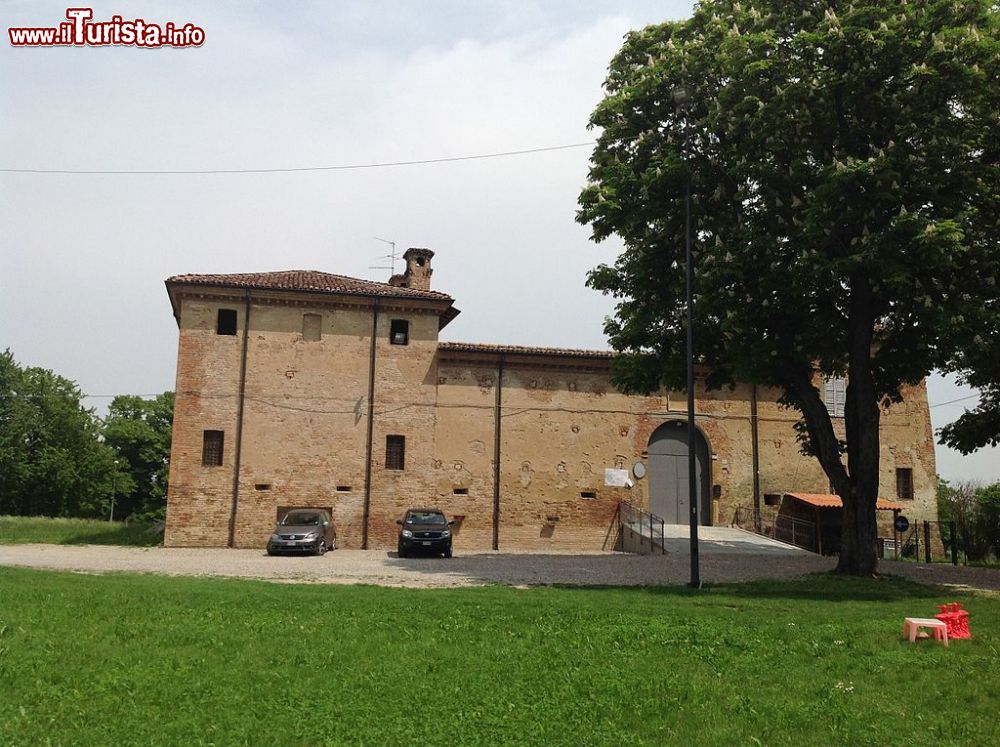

left=0, top=516, right=162, bottom=547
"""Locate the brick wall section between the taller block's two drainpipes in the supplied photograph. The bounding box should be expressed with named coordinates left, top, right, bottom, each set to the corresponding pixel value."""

left=235, top=305, right=371, bottom=547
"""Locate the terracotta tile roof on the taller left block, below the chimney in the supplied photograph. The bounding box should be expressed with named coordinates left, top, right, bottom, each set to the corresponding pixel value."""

left=167, top=270, right=453, bottom=301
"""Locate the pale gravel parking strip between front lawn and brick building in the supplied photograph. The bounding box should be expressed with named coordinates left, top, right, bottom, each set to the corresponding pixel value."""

left=0, top=545, right=1000, bottom=590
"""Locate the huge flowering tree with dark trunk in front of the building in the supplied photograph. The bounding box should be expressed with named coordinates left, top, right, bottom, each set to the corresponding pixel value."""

left=578, top=0, right=1000, bottom=574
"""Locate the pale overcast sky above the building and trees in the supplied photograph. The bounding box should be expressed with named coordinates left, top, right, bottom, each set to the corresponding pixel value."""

left=0, top=0, right=1000, bottom=480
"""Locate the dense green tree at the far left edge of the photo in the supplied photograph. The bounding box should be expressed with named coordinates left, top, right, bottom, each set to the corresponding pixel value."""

left=0, top=350, right=125, bottom=517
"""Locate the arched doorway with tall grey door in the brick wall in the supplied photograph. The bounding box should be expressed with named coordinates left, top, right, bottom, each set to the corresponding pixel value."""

left=648, top=420, right=712, bottom=525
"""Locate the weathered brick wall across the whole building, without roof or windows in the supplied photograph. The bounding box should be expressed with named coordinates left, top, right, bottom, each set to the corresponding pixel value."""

left=166, top=293, right=936, bottom=551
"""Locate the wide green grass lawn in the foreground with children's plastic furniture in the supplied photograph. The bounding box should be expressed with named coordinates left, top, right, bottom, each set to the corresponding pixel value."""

left=0, top=568, right=1000, bottom=747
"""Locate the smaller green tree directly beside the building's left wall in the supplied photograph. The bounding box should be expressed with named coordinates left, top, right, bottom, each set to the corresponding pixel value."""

left=103, top=392, right=174, bottom=519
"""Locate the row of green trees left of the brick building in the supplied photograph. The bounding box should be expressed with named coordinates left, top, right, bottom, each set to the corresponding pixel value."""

left=0, top=350, right=174, bottom=521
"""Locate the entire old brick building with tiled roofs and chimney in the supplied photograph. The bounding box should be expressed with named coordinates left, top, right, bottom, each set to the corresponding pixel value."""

left=165, top=249, right=936, bottom=550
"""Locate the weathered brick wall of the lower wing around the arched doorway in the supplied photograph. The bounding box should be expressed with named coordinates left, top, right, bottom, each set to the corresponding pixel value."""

left=439, top=361, right=935, bottom=549
